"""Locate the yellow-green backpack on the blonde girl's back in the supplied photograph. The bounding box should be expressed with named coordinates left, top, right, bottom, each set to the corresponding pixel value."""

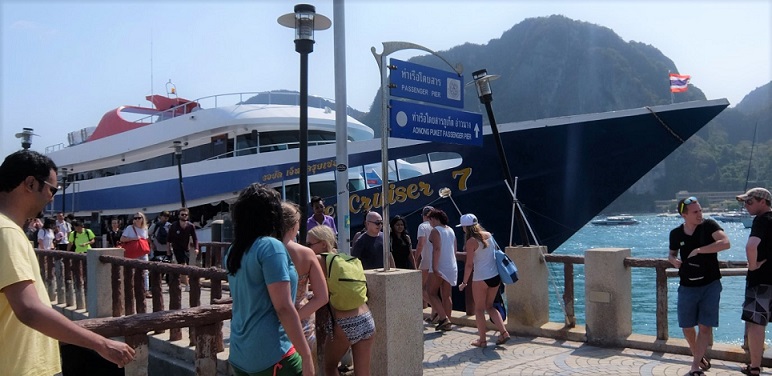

left=322, top=253, right=367, bottom=311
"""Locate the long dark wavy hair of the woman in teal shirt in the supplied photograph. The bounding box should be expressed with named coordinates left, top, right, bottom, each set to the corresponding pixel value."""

left=227, top=183, right=282, bottom=275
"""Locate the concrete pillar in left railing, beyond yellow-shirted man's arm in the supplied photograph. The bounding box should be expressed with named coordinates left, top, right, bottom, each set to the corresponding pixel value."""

left=86, top=248, right=123, bottom=319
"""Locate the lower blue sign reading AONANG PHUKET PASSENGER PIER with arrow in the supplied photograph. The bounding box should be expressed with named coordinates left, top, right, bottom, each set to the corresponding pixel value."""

left=389, top=100, right=483, bottom=146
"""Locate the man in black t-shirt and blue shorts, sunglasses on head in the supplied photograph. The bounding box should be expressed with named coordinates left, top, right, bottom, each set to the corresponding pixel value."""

left=668, top=197, right=730, bottom=376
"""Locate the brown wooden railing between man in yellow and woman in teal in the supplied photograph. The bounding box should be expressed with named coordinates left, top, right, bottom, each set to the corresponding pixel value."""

left=36, top=243, right=231, bottom=375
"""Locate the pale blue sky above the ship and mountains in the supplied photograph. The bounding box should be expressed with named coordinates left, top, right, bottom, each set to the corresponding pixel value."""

left=0, top=0, right=772, bottom=156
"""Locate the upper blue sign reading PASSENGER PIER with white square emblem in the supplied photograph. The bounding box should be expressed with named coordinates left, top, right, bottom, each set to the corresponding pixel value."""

left=389, top=59, right=464, bottom=108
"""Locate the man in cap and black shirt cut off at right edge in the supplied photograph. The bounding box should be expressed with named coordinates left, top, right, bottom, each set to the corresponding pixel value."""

left=737, top=188, right=772, bottom=375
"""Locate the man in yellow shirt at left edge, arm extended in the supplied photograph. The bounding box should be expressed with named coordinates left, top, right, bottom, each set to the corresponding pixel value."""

left=0, top=150, right=134, bottom=375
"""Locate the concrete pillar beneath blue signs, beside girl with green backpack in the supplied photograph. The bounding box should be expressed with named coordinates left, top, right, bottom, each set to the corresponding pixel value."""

left=365, top=269, right=424, bottom=375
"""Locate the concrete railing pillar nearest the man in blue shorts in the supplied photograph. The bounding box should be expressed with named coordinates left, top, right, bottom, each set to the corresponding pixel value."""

left=584, top=248, right=633, bottom=346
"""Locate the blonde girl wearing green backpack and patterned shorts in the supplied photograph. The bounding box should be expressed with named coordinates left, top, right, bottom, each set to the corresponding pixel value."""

left=306, top=226, right=375, bottom=375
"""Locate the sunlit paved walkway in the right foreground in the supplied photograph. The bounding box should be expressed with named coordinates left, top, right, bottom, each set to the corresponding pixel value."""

left=423, top=326, right=740, bottom=376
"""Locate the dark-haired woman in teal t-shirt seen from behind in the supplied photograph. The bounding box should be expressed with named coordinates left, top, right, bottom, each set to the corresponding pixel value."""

left=223, top=183, right=314, bottom=376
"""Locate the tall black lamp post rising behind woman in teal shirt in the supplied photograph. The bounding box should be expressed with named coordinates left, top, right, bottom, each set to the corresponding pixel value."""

left=277, top=4, right=332, bottom=243
